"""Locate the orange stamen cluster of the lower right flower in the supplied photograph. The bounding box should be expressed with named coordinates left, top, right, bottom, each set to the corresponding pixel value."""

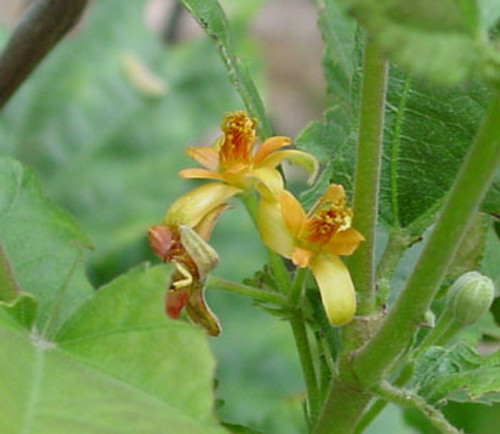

left=303, top=193, right=352, bottom=244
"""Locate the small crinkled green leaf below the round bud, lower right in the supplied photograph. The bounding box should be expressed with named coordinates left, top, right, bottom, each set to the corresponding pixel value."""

left=411, top=343, right=500, bottom=404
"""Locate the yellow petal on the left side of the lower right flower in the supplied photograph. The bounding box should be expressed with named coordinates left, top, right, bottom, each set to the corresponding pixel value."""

left=257, top=196, right=295, bottom=258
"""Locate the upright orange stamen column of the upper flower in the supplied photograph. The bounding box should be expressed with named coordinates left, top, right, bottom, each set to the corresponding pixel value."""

left=219, top=111, right=257, bottom=170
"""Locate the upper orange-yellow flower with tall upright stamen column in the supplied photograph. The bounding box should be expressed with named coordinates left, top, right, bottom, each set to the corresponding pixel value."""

left=179, top=111, right=318, bottom=193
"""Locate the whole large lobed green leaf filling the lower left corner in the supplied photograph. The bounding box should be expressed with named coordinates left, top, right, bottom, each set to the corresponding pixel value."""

left=0, top=157, right=223, bottom=434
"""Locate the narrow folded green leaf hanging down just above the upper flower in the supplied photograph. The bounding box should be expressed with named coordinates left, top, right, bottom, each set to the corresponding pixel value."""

left=182, top=0, right=272, bottom=138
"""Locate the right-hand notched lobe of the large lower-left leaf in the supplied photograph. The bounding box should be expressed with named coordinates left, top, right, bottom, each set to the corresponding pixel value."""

left=55, top=265, right=223, bottom=423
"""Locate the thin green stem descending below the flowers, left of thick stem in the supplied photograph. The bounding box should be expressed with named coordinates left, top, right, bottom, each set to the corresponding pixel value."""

left=290, top=310, right=320, bottom=426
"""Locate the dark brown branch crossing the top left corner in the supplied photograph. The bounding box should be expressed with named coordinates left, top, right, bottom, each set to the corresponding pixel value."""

left=0, top=0, right=88, bottom=108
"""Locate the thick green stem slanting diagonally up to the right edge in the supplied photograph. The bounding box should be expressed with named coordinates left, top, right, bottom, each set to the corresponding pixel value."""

left=318, top=90, right=500, bottom=434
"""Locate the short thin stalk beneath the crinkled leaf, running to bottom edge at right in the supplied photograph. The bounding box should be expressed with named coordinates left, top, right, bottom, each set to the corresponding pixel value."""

left=375, top=383, right=460, bottom=434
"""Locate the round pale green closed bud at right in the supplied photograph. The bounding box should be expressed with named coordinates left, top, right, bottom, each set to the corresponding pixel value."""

left=446, top=271, right=495, bottom=326
